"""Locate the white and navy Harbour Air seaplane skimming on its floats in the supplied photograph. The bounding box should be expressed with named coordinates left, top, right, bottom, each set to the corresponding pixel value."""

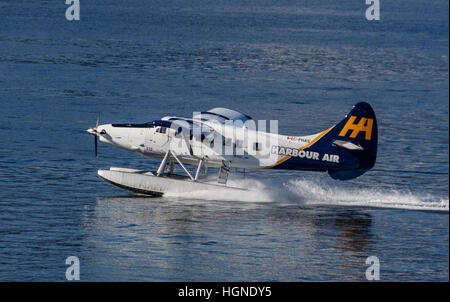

left=87, top=102, right=378, bottom=196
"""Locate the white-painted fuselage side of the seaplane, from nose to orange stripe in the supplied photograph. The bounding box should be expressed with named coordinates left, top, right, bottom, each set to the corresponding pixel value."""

left=97, top=122, right=323, bottom=169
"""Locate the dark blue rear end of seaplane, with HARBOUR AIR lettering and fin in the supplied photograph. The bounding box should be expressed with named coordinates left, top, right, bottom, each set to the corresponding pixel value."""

left=271, top=102, right=378, bottom=180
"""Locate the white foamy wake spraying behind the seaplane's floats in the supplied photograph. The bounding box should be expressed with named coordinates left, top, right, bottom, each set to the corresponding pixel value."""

left=164, top=178, right=449, bottom=212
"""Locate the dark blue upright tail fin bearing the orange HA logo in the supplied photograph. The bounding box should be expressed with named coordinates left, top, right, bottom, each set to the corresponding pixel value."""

left=314, top=102, right=378, bottom=180
